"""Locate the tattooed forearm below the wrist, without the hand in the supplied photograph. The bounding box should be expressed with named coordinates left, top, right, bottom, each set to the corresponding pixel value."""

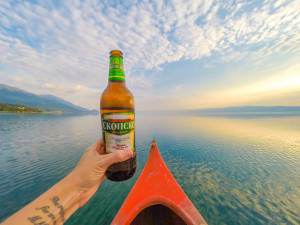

left=2, top=176, right=80, bottom=225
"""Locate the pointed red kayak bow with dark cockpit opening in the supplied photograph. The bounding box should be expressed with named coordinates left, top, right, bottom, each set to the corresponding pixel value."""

left=112, top=140, right=206, bottom=225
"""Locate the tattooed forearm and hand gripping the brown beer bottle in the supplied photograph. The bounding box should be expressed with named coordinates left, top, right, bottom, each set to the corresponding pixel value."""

left=1, top=138, right=133, bottom=225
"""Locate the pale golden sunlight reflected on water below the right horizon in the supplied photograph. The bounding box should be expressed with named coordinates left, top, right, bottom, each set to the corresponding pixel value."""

left=140, top=116, right=300, bottom=153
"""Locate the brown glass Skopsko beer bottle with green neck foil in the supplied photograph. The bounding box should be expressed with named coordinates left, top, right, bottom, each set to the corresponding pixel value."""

left=100, top=50, right=136, bottom=181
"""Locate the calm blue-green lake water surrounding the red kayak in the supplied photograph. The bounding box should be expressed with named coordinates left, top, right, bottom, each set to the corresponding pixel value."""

left=0, top=114, right=300, bottom=225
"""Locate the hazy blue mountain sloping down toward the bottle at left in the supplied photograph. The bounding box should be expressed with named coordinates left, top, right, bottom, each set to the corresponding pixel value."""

left=0, top=84, right=98, bottom=113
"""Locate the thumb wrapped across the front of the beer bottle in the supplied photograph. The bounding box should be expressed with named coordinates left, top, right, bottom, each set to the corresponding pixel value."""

left=101, top=149, right=133, bottom=167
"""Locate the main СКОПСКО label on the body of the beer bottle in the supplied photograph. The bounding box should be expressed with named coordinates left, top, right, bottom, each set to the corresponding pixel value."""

left=102, top=112, right=135, bottom=153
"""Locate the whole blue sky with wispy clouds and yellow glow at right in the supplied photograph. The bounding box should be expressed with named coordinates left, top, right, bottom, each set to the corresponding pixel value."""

left=0, top=0, right=300, bottom=110
